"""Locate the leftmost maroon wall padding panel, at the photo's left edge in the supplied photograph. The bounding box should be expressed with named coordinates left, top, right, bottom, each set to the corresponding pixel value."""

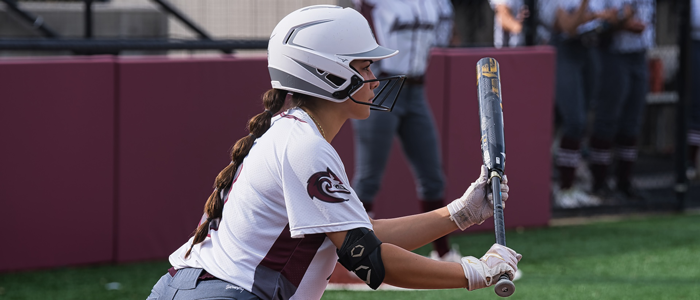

left=0, top=58, right=114, bottom=271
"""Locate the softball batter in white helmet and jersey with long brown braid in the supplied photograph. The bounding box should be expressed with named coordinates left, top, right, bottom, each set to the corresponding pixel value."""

left=148, top=6, right=521, bottom=299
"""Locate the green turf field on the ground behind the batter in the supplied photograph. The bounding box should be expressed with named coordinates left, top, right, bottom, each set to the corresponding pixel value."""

left=0, top=215, right=700, bottom=300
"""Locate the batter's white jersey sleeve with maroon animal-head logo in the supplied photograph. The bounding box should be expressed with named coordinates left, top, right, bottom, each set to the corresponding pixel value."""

left=282, top=137, right=372, bottom=238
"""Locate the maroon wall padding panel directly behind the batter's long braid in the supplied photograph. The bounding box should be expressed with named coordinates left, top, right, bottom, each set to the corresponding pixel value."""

left=116, top=58, right=270, bottom=261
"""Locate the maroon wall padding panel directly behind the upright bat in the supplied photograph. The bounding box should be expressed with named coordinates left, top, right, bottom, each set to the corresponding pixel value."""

left=435, top=47, right=555, bottom=231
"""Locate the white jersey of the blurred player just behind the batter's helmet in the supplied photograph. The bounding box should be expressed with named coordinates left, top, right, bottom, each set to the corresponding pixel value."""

left=354, top=0, right=453, bottom=77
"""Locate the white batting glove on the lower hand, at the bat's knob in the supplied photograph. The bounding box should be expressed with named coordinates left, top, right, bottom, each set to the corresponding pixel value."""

left=462, top=244, right=523, bottom=291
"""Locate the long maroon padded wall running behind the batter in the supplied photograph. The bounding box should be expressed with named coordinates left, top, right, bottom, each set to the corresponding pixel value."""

left=0, top=48, right=554, bottom=271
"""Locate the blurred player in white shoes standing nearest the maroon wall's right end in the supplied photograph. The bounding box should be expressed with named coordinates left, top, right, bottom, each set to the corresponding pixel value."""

left=538, top=0, right=600, bottom=208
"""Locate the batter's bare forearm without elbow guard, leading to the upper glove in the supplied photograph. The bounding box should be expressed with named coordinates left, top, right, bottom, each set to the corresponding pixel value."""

left=372, top=207, right=457, bottom=250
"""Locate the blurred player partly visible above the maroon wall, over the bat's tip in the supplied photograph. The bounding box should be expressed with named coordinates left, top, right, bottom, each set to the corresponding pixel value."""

left=489, top=0, right=529, bottom=48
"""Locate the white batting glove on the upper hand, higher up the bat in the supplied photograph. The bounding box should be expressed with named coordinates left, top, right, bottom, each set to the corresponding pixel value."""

left=447, top=165, right=510, bottom=230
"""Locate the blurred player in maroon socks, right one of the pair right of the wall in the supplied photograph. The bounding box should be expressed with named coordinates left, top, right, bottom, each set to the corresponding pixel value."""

left=589, top=0, right=656, bottom=202
